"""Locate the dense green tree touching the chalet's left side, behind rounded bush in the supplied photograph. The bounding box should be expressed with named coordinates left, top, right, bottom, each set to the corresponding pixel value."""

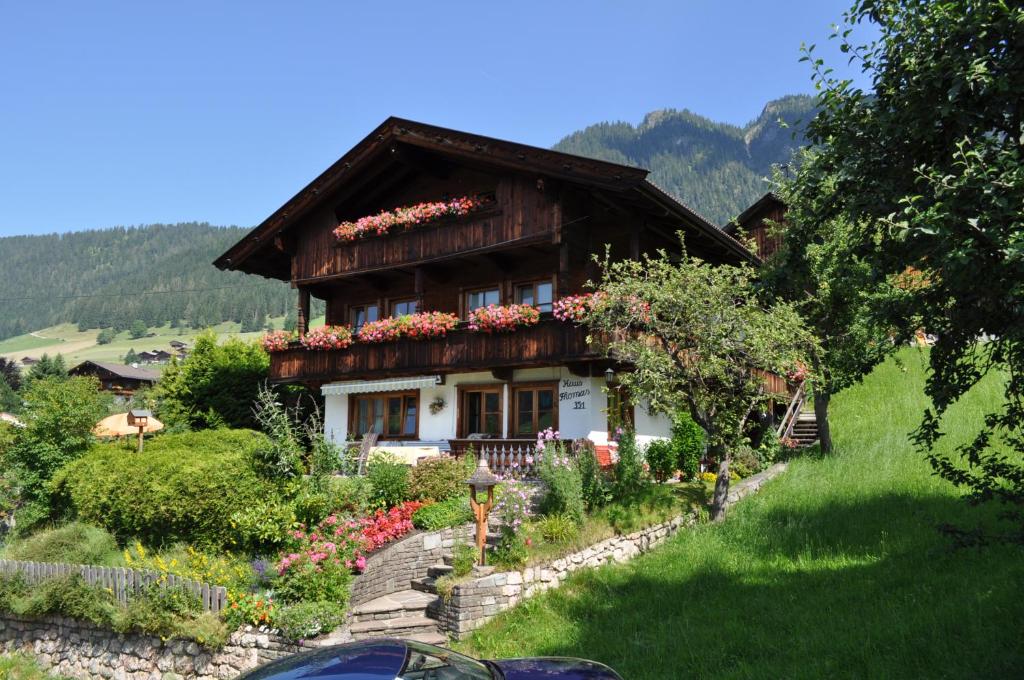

left=153, top=331, right=270, bottom=428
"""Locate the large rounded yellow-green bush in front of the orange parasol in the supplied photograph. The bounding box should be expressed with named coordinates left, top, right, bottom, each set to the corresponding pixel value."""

left=53, top=430, right=276, bottom=547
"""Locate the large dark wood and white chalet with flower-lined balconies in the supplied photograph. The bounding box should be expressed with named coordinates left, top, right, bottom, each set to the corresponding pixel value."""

left=216, top=118, right=752, bottom=451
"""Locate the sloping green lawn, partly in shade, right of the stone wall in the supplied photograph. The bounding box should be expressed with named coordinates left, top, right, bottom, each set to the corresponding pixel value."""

left=458, top=350, right=1024, bottom=680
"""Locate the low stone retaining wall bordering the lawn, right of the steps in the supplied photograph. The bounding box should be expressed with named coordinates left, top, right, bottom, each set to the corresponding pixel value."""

left=440, top=463, right=785, bottom=640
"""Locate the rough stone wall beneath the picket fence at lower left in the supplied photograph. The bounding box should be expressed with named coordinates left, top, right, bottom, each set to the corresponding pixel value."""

left=0, top=614, right=305, bottom=680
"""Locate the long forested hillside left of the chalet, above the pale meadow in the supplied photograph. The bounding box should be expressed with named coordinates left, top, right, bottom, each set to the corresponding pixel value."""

left=0, top=222, right=295, bottom=339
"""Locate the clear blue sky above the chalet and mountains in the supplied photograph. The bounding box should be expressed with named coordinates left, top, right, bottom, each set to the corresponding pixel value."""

left=0, top=0, right=872, bottom=236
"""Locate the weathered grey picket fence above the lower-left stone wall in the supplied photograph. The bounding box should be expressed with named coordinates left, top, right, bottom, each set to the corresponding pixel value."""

left=0, top=559, right=227, bottom=613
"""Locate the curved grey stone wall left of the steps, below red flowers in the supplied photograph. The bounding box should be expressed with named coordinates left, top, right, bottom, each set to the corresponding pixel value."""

left=349, top=524, right=474, bottom=606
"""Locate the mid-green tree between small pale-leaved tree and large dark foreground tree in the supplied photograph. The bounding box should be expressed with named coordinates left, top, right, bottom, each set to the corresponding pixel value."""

left=760, top=175, right=903, bottom=453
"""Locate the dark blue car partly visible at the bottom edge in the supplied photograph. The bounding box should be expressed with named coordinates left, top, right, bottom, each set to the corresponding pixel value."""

left=239, top=639, right=623, bottom=680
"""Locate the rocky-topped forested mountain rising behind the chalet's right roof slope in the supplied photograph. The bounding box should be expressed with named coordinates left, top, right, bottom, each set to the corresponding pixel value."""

left=555, top=95, right=814, bottom=224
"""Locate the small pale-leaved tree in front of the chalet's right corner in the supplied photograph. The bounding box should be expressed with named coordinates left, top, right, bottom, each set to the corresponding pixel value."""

left=588, top=253, right=814, bottom=519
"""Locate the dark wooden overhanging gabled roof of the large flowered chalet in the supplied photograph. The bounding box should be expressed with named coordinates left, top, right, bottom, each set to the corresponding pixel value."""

left=214, top=117, right=751, bottom=281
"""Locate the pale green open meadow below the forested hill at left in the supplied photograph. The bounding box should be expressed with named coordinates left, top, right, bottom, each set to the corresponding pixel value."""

left=0, top=316, right=324, bottom=371
